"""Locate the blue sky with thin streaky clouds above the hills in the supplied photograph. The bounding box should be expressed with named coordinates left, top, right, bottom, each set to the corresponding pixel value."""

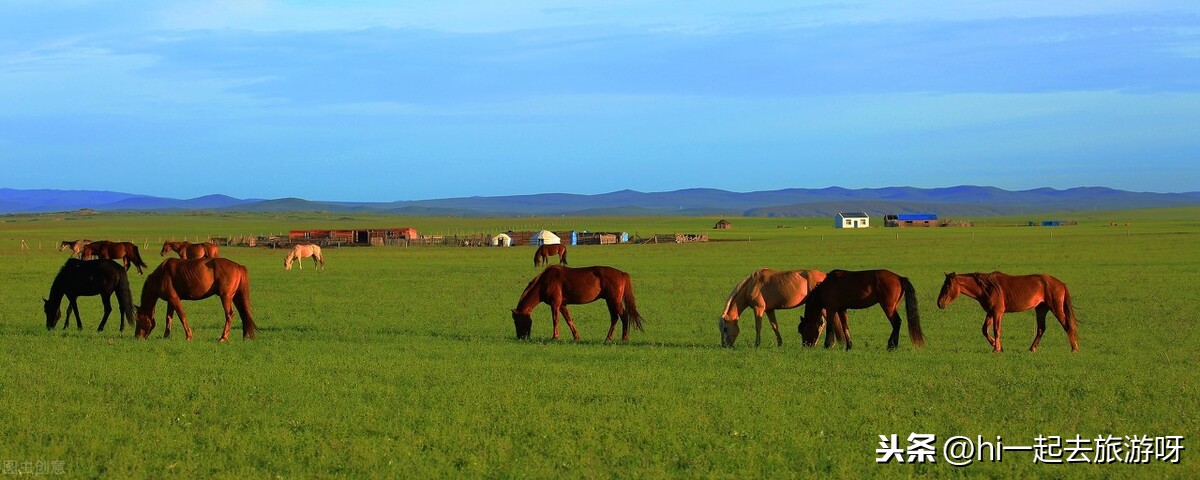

left=0, top=0, right=1200, bottom=202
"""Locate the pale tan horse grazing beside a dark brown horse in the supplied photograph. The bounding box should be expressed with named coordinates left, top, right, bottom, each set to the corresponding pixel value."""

left=718, top=269, right=826, bottom=347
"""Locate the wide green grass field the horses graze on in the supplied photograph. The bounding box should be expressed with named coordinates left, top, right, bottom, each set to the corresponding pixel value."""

left=0, top=209, right=1200, bottom=478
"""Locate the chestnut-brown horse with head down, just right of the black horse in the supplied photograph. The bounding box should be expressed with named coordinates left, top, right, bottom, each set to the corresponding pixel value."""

left=134, top=258, right=256, bottom=342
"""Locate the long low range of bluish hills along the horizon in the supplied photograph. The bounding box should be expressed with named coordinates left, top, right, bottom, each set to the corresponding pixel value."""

left=0, top=186, right=1200, bottom=217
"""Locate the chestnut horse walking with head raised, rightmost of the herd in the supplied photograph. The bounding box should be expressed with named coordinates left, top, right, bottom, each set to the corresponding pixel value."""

left=937, top=271, right=1079, bottom=352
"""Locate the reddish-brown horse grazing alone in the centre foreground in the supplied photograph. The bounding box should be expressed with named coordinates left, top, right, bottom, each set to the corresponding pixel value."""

left=512, top=265, right=642, bottom=342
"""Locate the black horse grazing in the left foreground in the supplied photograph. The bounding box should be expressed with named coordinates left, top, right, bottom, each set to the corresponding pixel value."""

left=42, top=258, right=134, bottom=331
